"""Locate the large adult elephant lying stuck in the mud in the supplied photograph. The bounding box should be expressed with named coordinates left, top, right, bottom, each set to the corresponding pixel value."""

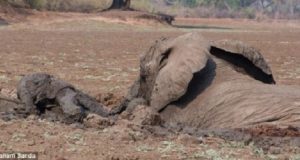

left=119, top=33, right=300, bottom=129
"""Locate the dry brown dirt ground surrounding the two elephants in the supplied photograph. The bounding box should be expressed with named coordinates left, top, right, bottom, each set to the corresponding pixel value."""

left=0, top=11, right=300, bottom=160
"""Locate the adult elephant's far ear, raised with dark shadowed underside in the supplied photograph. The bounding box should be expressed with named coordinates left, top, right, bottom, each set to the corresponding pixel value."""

left=210, top=40, right=276, bottom=84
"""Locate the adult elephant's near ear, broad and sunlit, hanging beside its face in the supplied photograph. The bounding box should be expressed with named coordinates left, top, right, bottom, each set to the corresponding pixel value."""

left=150, top=33, right=209, bottom=111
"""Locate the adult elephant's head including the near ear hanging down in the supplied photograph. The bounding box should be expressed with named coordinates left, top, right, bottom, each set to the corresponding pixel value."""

left=138, top=34, right=209, bottom=111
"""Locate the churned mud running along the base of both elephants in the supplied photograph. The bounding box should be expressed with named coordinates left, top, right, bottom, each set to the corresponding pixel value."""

left=0, top=98, right=300, bottom=154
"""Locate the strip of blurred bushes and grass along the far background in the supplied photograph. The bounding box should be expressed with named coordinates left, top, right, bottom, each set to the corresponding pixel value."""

left=0, top=0, right=300, bottom=18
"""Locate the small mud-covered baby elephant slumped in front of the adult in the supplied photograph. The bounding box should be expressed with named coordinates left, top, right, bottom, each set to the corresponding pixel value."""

left=17, top=73, right=109, bottom=121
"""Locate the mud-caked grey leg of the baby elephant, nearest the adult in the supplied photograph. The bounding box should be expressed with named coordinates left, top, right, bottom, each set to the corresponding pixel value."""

left=56, top=88, right=85, bottom=121
